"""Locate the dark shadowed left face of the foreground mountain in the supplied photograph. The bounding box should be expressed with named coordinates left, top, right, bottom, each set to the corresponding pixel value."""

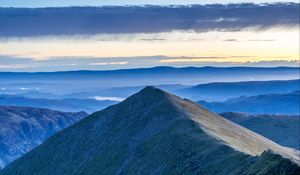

left=0, top=90, right=298, bottom=175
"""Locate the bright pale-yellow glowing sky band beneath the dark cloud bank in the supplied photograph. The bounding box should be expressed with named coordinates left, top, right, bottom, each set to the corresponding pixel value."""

left=0, top=28, right=299, bottom=62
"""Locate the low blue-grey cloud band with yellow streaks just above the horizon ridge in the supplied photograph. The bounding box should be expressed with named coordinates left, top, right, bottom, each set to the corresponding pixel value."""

left=0, top=55, right=300, bottom=72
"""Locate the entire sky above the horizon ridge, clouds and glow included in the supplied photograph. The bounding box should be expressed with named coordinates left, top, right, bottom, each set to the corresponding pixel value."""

left=0, top=0, right=299, bottom=72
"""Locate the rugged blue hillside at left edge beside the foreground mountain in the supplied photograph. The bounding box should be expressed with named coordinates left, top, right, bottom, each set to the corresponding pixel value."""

left=0, top=106, right=88, bottom=169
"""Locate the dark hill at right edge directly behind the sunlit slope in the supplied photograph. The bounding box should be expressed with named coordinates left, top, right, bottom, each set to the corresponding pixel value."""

left=220, top=112, right=300, bottom=150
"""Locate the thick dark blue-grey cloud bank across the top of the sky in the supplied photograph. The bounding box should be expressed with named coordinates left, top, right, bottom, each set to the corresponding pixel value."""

left=0, top=3, right=299, bottom=37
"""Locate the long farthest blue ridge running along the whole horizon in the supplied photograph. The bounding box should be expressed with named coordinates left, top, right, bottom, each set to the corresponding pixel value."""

left=0, top=66, right=300, bottom=81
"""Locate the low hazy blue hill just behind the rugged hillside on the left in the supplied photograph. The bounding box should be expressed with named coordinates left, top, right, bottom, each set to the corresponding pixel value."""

left=0, top=94, right=116, bottom=113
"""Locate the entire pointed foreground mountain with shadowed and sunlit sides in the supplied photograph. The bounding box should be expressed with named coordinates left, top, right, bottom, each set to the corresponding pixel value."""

left=0, top=87, right=300, bottom=175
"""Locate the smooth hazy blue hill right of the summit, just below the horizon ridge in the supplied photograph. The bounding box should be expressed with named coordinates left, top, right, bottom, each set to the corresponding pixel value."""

left=176, top=79, right=300, bottom=101
